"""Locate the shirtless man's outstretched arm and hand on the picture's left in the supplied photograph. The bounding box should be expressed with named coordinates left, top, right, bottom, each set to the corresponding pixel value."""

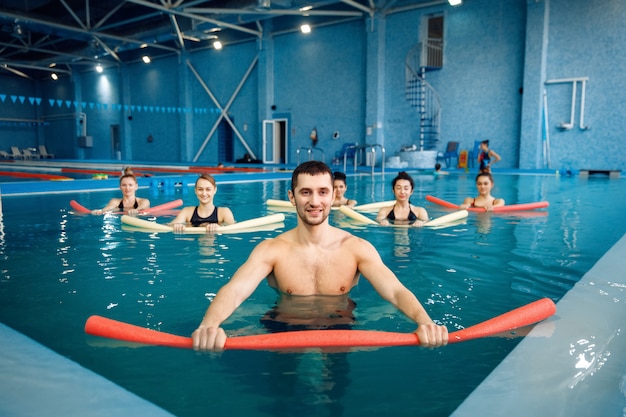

left=191, top=240, right=274, bottom=351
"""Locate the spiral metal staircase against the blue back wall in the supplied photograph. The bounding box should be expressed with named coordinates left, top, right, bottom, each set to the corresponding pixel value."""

left=405, top=39, right=443, bottom=151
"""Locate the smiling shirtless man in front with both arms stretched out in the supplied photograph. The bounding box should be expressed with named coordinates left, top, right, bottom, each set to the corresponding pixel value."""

left=192, top=161, right=448, bottom=351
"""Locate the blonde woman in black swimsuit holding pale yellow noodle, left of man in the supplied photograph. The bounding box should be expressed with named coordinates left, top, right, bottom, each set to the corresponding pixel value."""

left=170, top=174, right=235, bottom=232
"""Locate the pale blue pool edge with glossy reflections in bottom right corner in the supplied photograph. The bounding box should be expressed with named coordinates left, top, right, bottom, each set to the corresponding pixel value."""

left=451, top=235, right=626, bottom=417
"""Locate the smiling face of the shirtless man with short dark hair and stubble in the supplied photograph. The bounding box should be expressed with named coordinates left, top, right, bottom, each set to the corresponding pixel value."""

left=289, top=174, right=333, bottom=226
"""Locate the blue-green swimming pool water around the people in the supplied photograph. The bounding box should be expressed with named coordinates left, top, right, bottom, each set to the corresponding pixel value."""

left=0, top=174, right=626, bottom=416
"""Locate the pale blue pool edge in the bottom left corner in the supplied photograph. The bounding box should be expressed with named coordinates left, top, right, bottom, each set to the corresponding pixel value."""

left=0, top=323, right=172, bottom=417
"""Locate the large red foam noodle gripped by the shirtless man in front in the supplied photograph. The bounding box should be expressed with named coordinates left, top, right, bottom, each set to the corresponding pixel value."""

left=85, top=298, right=556, bottom=350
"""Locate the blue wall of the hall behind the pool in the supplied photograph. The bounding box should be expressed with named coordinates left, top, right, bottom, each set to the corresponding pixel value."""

left=0, top=0, right=626, bottom=170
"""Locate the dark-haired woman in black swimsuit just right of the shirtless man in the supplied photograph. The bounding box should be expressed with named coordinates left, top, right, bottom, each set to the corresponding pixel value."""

left=376, top=171, right=428, bottom=227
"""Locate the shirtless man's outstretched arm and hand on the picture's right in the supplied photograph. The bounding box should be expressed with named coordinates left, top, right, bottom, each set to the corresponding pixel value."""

left=354, top=239, right=448, bottom=347
